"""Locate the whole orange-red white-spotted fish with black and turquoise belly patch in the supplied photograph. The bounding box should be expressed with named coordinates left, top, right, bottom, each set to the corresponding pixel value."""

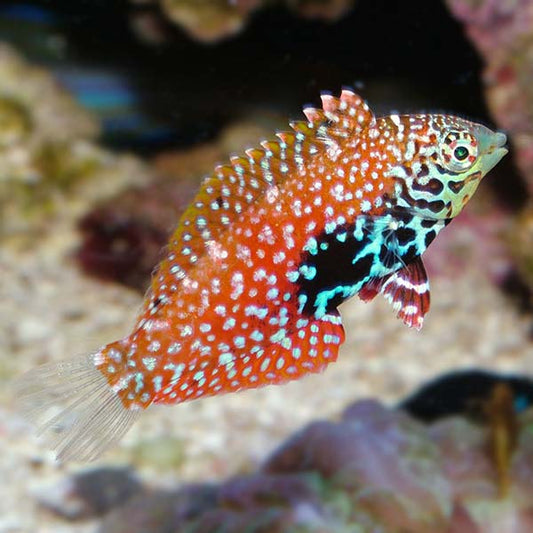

left=17, top=90, right=507, bottom=460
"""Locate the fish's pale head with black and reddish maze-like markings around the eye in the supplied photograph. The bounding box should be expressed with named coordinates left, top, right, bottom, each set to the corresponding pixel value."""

left=380, top=115, right=507, bottom=219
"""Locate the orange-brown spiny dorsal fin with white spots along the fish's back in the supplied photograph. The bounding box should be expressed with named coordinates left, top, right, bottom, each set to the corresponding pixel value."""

left=160, top=90, right=374, bottom=280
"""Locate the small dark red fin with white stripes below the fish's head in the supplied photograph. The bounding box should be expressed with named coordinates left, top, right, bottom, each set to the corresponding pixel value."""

left=359, top=257, right=430, bottom=329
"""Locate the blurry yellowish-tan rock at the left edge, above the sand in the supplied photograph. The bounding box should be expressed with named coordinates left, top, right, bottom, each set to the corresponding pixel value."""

left=0, top=44, right=149, bottom=240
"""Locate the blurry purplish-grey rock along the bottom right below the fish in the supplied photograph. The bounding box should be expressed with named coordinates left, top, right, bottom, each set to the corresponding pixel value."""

left=30, top=388, right=533, bottom=533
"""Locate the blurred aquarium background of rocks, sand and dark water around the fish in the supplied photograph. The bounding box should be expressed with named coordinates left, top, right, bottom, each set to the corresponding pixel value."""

left=0, top=0, right=533, bottom=533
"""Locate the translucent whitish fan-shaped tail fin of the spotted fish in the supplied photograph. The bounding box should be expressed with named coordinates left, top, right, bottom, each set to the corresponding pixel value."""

left=15, top=353, right=140, bottom=461
